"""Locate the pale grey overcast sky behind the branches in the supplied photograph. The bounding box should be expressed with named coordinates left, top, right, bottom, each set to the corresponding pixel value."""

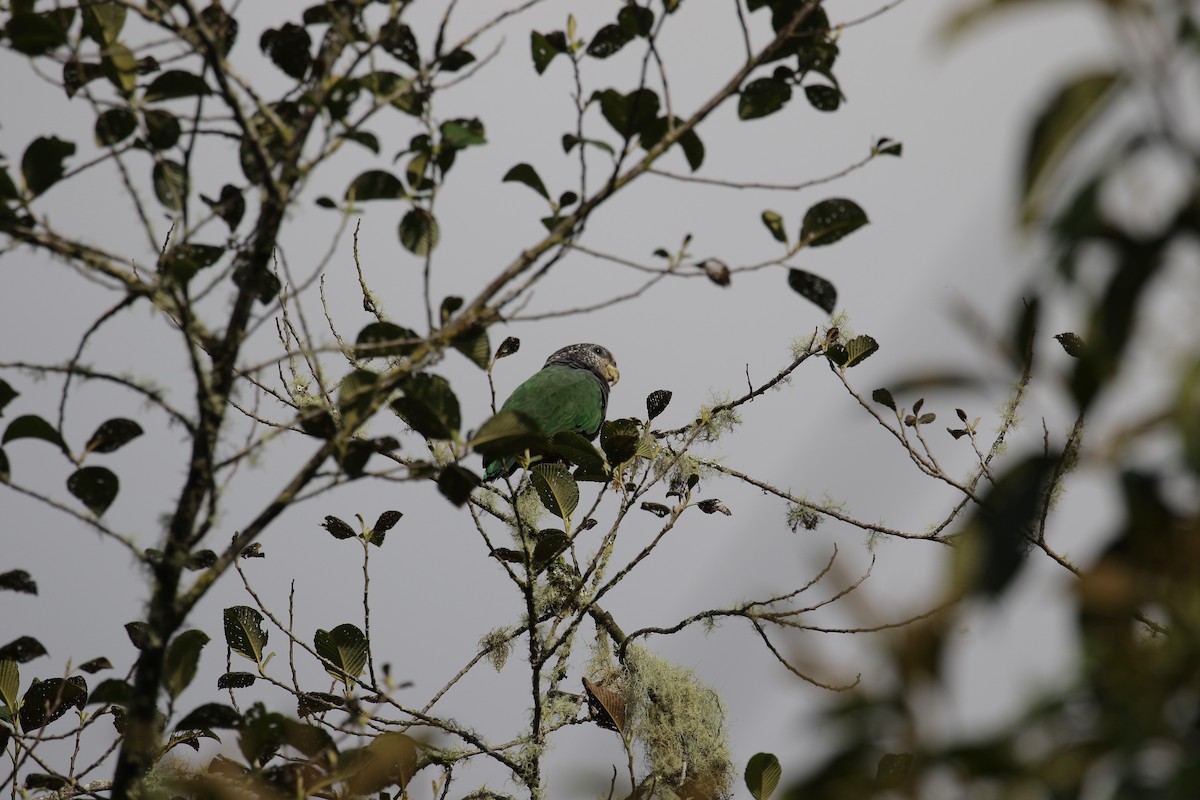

left=0, top=0, right=1128, bottom=796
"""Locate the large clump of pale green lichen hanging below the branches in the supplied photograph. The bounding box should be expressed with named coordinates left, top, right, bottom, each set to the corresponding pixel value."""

left=617, top=645, right=733, bottom=798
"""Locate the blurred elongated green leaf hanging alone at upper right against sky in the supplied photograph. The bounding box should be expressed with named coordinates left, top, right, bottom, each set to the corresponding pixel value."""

left=1021, top=72, right=1122, bottom=223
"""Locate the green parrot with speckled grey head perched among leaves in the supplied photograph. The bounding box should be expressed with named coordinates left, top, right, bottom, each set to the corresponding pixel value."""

left=484, top=343, right=620, bottom=481
